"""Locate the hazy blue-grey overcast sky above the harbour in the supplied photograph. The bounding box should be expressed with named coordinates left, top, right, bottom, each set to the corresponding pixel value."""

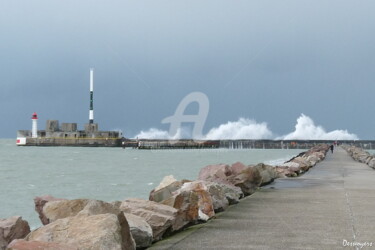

left=0, top=0, right=375, bottom=139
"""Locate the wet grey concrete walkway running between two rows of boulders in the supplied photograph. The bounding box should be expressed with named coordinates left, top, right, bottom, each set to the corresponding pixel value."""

left=150, top=148, right=375, bottom=249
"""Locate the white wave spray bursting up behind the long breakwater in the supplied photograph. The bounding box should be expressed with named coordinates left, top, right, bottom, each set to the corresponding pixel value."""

left=135, top=114, right=359, bottom=140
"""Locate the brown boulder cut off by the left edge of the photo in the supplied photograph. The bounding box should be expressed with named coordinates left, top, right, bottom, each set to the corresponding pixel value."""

left=0, top=216, right=30, bottom=250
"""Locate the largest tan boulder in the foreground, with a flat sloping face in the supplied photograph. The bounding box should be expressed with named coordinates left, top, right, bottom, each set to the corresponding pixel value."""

left=26, top=213, right=135, bottom=250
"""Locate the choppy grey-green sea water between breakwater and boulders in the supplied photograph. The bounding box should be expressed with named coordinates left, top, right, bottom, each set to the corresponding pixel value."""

left=0, top=139, right=303, bottom=228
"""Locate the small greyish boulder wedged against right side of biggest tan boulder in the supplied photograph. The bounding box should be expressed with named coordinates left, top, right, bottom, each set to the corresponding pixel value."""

left=125, top=213, right=153, bottom=249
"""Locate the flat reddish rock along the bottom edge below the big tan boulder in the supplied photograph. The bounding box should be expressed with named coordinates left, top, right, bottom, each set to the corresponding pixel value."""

left=7, top=240, right=78, bottom=250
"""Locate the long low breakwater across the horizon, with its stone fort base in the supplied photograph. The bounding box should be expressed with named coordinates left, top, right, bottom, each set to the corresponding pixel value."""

left=17, top=138, right=375, bottom=150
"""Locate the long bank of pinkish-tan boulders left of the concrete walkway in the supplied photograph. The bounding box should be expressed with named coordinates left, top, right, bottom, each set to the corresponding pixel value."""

left=0, top=144, right=329, bottom=250
